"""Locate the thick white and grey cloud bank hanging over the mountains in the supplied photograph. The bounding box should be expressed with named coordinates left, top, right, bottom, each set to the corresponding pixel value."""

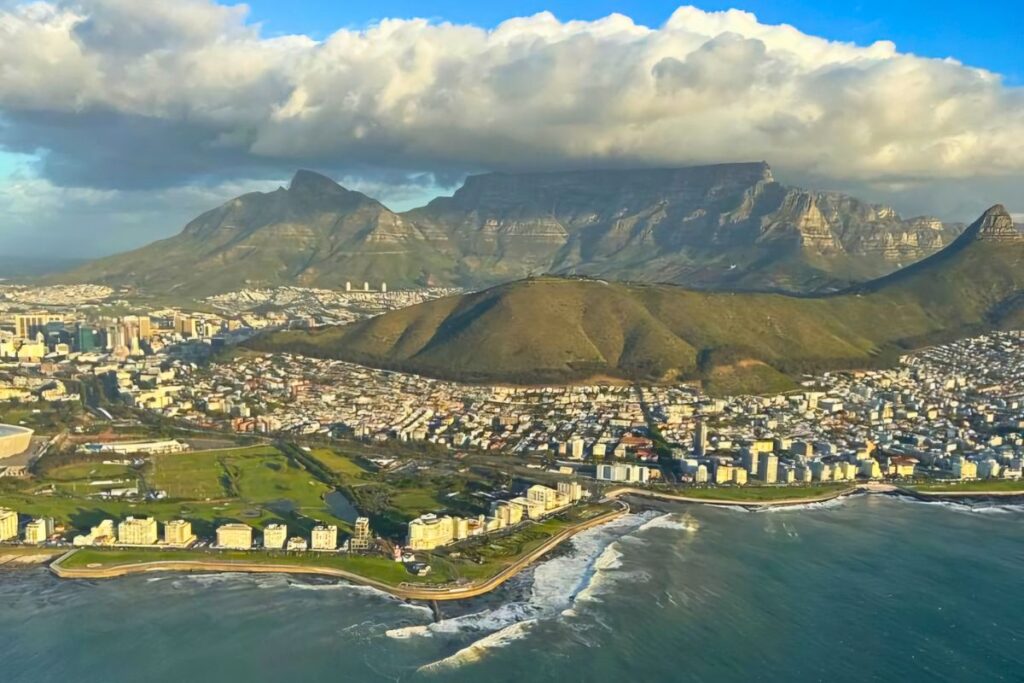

left=0, top=0, right=1024, bottom=255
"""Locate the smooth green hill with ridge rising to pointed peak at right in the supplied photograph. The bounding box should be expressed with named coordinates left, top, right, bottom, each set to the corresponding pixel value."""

left=252, top=206, right=1024, bottom=391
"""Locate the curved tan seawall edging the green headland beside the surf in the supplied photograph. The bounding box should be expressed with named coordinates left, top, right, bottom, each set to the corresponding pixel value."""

left=49, top=501, right=630, bottom=602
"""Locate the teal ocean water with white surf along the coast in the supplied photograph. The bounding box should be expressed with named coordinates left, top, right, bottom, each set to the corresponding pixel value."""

left=0, top=496, right=1024, bottom=683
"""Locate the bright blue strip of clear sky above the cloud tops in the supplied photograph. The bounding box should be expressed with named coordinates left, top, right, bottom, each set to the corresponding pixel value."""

left=247, top=0, right=1024, bottom=84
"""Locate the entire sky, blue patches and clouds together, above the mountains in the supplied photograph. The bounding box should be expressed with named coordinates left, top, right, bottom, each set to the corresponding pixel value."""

left=0, top=0, right=1024, bottom=257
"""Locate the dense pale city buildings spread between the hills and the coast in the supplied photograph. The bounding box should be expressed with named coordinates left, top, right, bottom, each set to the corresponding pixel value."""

left=0, top=283, right=1024, bottom=559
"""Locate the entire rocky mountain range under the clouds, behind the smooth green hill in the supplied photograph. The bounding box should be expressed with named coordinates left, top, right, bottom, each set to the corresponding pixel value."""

left=59, top=162, right=963, bottom=296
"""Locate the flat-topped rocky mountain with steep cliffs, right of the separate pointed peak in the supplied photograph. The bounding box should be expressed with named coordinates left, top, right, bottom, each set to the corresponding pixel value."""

left=407, top=163, right=962, bottom=290
